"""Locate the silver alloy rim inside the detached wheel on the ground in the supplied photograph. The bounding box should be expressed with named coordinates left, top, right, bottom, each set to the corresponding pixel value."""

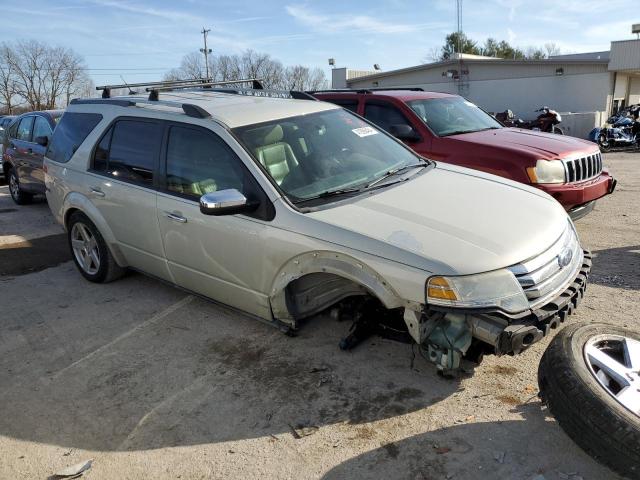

left=584, top=335, right=640, bottom=417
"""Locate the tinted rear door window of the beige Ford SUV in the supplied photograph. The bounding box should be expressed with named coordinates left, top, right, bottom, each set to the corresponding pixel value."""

left=93, top=119, right=164, bottom=186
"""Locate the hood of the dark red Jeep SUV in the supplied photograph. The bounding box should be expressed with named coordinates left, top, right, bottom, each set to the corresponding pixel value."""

left=447, top=128, right=598, bottom=160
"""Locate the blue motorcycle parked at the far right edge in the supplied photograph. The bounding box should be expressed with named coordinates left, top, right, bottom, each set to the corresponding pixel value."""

left=587, top=104, right=640, bottom=152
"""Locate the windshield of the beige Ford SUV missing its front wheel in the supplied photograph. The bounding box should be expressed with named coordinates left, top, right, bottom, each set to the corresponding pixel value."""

left=234, top=109, right=423, bottom=203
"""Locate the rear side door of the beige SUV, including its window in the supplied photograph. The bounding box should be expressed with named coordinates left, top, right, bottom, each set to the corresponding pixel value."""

left=90, top=117, right=170, bottom=280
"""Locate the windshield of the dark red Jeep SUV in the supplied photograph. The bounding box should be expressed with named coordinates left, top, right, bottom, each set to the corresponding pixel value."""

left=407, top=97, right=502, bottom=137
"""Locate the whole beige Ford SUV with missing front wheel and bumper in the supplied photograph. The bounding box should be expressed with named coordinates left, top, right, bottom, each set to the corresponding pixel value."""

left=45, top=89, right=591, bottom=374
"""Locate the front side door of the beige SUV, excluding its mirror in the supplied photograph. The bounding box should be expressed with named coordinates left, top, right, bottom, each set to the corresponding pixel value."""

left=158, top=124, right=271, bottom=319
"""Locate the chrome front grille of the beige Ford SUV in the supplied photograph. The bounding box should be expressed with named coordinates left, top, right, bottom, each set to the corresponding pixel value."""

left=509, top=225, right=584, bottom=308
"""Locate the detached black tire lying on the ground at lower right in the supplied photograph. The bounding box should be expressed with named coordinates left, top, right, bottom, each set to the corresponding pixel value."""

left=538, top=324, right=640, bottom=479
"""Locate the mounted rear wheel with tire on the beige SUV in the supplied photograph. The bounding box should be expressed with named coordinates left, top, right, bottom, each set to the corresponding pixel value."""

left=67, top=212, right=125, bottom=283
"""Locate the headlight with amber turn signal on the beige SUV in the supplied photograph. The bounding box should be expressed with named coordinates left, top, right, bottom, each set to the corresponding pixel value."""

left=427, top=270, right=529, bottom=313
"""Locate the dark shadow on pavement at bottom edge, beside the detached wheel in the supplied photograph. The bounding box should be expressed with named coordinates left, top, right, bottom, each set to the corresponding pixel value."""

left=322, top=402, right=620, bottom=480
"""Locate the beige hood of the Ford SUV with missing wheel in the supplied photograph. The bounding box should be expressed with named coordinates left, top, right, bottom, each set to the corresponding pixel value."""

left=306, top=164, right=568, bottom=275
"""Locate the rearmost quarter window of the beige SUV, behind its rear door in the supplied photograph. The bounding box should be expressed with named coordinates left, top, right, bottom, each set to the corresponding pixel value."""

left=46, top=112, right=102, bottom=163
